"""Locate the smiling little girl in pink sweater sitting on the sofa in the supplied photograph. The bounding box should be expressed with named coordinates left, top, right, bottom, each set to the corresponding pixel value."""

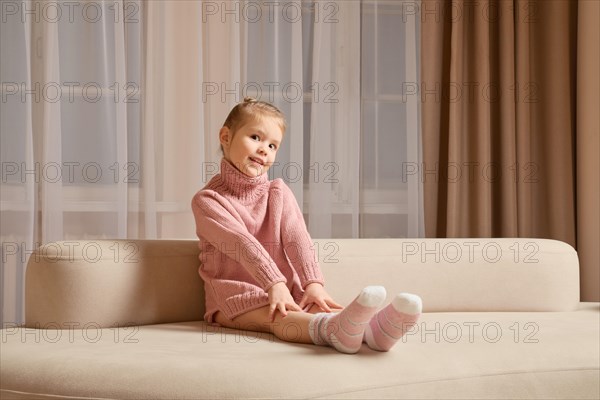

left=192, top=98, right=422, bottom=353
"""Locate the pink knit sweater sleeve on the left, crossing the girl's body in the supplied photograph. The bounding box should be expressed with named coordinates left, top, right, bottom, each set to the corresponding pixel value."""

left=192, top=191, right=287, bottom=291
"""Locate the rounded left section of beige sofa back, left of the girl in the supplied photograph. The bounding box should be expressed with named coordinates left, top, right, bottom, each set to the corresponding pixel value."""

left=25, top=240, right=204, bottom=329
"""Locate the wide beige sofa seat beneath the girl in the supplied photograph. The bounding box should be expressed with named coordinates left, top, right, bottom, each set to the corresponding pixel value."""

left=1, top=303, right=600, bottom=399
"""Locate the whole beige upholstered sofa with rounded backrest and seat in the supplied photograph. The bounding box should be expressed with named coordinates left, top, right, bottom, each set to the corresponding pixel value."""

left=0, top=239, right=600, bottom=399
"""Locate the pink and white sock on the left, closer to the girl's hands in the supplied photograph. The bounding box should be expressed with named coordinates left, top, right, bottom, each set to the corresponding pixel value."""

left=308, top=286, right=386, bottom=354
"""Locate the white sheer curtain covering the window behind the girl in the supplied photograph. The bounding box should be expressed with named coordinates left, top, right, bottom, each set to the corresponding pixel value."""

left=0, top=0, right=423, bottom=323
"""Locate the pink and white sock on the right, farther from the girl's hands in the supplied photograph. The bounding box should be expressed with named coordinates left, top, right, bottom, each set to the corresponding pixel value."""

left=365, top=293, right=423, bottom=351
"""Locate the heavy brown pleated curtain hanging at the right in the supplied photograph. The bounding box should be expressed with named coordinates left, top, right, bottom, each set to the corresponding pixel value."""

left=421, top=0, right=600, bottom=301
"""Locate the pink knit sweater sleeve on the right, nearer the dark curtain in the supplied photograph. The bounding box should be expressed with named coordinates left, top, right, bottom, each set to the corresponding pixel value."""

left=281, top=181, right=325, bottom=289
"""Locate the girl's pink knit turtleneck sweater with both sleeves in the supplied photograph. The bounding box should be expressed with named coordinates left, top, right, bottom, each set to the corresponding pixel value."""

left=192, top=159, right=324, bottom=323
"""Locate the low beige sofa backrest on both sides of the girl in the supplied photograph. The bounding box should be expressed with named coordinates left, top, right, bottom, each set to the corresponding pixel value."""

left=25, top=239, right=579, bottom=328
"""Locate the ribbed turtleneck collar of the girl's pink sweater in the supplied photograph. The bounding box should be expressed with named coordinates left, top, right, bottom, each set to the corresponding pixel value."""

left=221, top=157, right=269, bottom=201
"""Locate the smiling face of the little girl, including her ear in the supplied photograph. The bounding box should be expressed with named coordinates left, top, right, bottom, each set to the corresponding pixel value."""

left=219, top=117, right=283, bottom=178
